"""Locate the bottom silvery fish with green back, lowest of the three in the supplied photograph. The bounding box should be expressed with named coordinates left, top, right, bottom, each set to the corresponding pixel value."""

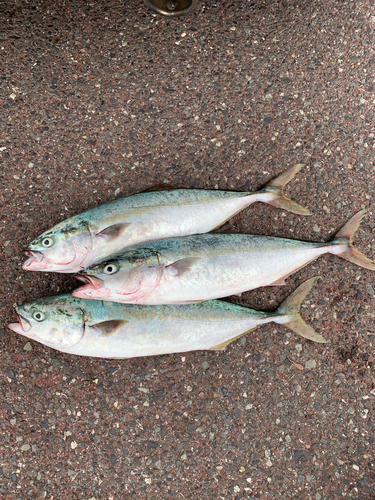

left=9, top=277, right=327, bottom=358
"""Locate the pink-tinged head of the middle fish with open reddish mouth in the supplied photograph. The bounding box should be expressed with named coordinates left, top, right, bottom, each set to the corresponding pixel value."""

left=72, top=250, right=161, bottom=302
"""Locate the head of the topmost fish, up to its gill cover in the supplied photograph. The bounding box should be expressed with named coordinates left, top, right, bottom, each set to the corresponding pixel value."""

left=22, top=218, right=93, bottom=273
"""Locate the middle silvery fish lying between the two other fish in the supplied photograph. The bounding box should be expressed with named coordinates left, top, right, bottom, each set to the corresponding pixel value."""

left=73, top=210, right=375, bottom=305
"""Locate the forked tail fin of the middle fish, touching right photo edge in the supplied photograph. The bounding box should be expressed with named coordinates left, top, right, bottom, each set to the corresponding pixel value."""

left=330, top=209, right=375, bottom=271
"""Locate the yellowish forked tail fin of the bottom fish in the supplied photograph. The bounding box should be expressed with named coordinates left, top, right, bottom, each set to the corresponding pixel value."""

left=275, top=276, right=327, bottom=343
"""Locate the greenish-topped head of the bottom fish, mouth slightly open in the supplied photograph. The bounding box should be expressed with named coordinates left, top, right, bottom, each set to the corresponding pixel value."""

left=9, top=294, right=85, bottom=350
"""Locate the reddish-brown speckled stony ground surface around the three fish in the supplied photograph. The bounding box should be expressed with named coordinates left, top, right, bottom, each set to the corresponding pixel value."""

left=0, top=0, right=375, bottom=500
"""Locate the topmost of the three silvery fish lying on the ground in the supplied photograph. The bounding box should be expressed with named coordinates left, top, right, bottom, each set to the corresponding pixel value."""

left=22, top=163, right=310, bottom=273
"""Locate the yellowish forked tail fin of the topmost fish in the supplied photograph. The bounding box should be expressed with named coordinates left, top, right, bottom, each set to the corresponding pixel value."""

left=264, top=163, right=311, bottom=215
